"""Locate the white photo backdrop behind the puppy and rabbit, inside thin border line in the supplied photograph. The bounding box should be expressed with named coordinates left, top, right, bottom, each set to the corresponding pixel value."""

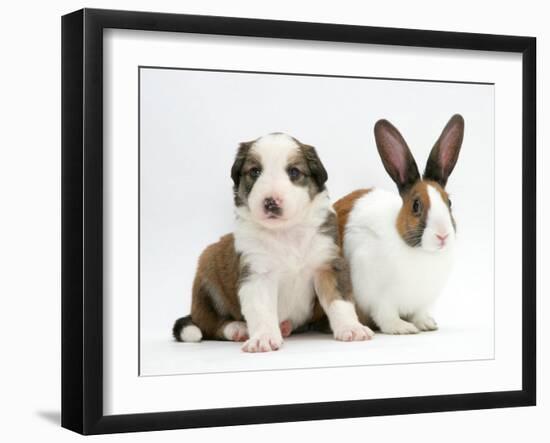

left=140, top=67, right=498, bottom=375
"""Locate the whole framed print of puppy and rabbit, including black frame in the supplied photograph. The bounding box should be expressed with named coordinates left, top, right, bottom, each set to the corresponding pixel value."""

left=62, top=9, right=536, bottom=434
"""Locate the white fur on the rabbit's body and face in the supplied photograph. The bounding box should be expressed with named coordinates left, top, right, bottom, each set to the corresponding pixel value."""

left=344, top=185, right=455, bottom=334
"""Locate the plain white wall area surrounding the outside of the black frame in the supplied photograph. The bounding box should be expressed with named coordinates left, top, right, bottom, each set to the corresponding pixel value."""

left=0, top=1, right=550, bottom=442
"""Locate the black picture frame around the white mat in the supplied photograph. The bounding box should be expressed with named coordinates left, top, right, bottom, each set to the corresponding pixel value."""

left=61, top=9, right=537, bottom=434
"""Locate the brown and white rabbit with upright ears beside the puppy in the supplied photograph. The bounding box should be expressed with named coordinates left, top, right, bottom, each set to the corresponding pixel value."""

left=334, top=114, right=464, bottom=334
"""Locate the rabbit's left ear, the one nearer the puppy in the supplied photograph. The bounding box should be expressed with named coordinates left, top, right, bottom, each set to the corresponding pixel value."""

left=374, top=120, right=420, bottom=195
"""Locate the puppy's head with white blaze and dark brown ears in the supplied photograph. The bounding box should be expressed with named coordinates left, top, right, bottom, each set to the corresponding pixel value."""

left=231, top=133, right=328, bottom=229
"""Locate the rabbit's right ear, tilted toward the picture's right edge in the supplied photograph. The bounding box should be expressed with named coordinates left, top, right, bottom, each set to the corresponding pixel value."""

left=424, top=114, right=464, bottom=187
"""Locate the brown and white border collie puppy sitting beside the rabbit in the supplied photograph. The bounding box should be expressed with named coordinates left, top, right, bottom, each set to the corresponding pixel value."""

left=173, top=133, right=373, bottom=352
